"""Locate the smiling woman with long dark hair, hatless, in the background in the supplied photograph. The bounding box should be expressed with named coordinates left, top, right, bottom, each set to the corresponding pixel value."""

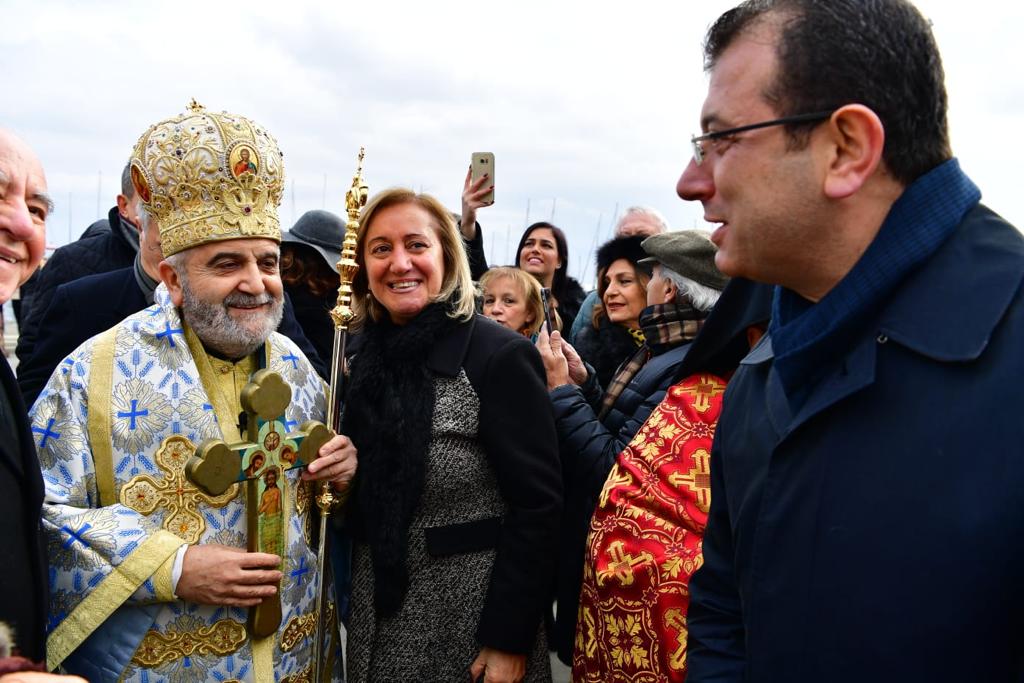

left=515, top=221, right=587, bottom=330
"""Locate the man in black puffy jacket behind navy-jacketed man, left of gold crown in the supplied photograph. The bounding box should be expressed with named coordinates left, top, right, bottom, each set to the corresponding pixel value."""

left=14, top=166, right=139, bottom=370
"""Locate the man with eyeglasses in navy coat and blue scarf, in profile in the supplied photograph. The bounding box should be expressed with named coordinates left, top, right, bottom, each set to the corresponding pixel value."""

left=678, top=0, right=1024, bottom=683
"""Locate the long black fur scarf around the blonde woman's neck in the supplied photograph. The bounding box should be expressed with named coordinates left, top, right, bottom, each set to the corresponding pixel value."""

left=341, top=304, right=457, bottom=615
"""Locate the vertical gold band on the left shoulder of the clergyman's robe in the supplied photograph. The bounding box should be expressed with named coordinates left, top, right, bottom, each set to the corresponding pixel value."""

left=88, top=327, right=118, bottom=508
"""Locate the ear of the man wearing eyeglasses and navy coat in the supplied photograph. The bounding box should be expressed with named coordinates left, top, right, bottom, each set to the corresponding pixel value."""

left=824, top=104, right=886, bottom=200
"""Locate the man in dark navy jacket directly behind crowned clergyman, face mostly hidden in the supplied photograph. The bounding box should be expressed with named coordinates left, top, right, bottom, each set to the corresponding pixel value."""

left=17, top=198, right=328, bottom=407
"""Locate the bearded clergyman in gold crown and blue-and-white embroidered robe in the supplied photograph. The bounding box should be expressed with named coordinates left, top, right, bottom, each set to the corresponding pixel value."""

left=33, top=102, right=355, bottom=681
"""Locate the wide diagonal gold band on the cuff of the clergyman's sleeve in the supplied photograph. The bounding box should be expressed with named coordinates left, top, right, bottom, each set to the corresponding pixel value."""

left=46, top=529, right=184, bottom=671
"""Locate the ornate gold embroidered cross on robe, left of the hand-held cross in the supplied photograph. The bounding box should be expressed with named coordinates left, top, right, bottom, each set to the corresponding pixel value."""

left=120, top=435, right=239, bottom=544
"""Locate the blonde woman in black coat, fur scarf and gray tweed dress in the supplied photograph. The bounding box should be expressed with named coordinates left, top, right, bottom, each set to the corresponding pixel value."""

left=342, top=188, right=562, bottom=683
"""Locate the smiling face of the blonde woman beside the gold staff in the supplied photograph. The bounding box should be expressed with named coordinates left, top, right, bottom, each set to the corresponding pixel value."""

left=362, top=204, right=444, bottom=325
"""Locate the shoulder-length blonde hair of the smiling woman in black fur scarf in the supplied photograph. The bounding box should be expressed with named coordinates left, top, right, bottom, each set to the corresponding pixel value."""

left=352, top=187, right=475, bottom=329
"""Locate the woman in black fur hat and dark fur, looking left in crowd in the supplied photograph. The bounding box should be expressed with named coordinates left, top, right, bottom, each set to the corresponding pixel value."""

left=573, top=236, right=651, bottom=389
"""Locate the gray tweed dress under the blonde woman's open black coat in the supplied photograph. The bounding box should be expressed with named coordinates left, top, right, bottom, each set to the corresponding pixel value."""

left=346, top=371, right=551, bottom=683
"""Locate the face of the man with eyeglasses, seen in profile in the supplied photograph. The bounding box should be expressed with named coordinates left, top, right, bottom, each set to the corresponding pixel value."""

left=676, top=19, right=828, bottom=285
